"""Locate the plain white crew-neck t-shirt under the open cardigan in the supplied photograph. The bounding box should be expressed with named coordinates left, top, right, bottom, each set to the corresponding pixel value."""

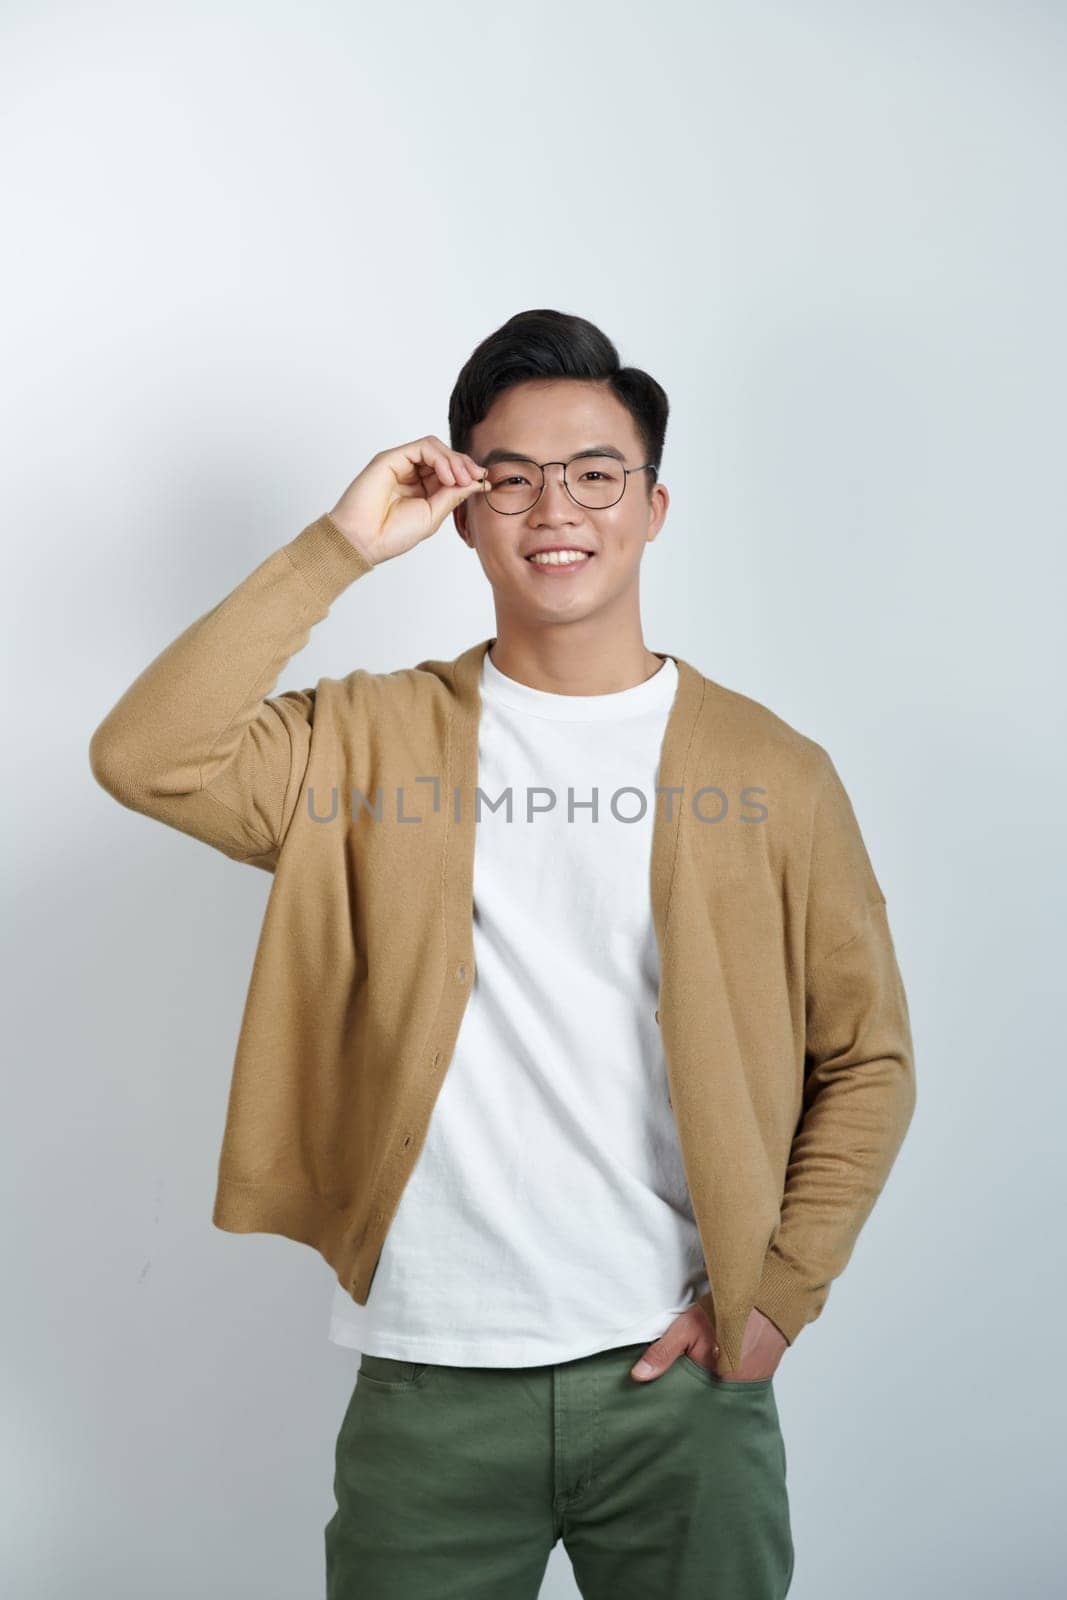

left=330, top=651, right=709, bottom=1366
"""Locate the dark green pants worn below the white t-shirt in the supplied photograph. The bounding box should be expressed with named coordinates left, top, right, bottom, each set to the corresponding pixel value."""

left=325, top=1339, right=793, bottom=1600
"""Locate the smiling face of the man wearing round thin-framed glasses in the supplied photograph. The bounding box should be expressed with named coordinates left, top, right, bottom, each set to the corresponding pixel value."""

left=453, top=378, right=669, bottom=622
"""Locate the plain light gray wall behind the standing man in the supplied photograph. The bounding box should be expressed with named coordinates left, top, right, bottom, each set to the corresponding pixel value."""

left=0, top=0, right=1067, bottom=1600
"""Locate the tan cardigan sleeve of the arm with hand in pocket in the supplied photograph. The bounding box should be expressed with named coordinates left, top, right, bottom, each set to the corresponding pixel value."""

left=755, top=752, right=915, bottom=1344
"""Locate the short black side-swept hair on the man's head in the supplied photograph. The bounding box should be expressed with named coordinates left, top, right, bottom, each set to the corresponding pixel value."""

left=448, top=310, right=670, bottom=493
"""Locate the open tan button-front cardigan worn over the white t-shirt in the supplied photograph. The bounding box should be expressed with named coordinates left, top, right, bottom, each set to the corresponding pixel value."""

left=90, top=515, right=915, bottom=1371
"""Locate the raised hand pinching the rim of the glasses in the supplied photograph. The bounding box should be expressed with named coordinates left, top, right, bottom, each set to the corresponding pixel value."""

left=330, top=434, right=485, bottom=566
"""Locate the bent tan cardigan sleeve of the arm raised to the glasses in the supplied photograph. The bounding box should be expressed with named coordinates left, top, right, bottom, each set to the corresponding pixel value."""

left=90, top=514, right=373, bottom=872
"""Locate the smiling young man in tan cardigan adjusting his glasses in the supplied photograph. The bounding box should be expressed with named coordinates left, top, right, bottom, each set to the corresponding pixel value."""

left=91, top=310, right=915, bottom=1600
